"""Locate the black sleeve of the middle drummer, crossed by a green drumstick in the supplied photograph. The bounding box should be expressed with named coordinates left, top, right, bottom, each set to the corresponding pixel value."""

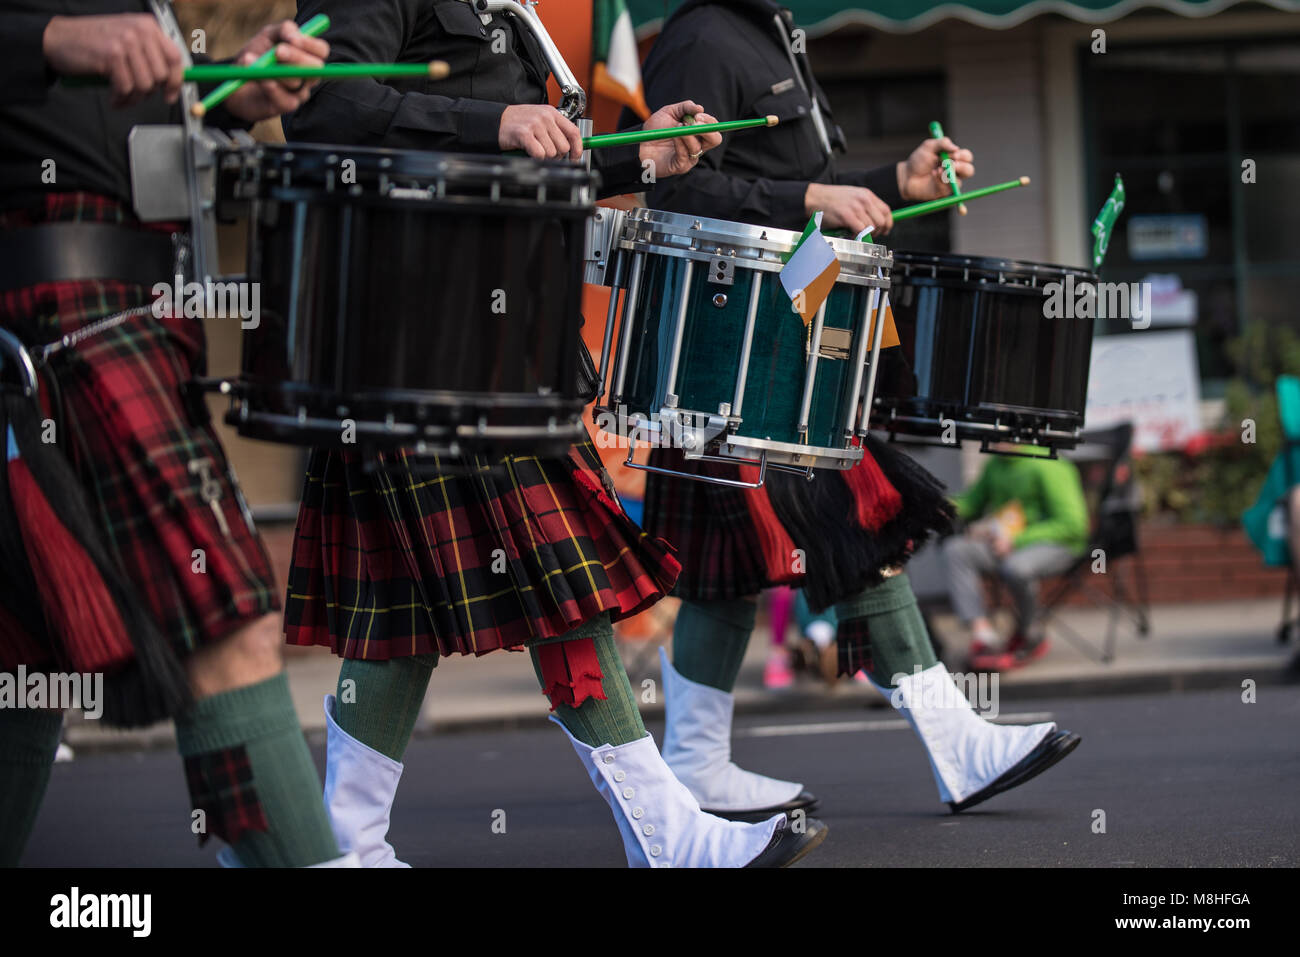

left=283, top=0, right=506, bottom=151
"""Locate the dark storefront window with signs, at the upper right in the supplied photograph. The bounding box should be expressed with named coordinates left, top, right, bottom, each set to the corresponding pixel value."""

left=1080, top=38, right=1300, bottom=394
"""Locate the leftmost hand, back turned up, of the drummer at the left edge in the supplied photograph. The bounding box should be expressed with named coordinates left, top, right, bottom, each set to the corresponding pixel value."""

left=42, top=13, right=183, bottom=107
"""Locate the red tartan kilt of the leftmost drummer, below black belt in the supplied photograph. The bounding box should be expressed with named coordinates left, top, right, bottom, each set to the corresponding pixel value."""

left=0, top=194, right=280, bottom=681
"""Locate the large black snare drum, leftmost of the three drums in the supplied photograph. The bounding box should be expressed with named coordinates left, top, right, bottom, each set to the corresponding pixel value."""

left=220, top=144, right=594, bottom=455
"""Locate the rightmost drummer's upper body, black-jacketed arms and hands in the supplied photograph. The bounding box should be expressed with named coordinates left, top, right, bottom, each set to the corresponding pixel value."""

left=623, top=0, right=975, bottom=235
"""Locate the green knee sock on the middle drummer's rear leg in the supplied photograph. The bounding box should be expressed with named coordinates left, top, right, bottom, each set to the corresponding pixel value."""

left=334, top=654, right=438, bottom=761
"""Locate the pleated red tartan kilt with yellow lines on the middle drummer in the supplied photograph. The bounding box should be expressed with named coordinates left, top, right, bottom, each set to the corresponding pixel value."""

left=285, top=439, right=680, bottom=661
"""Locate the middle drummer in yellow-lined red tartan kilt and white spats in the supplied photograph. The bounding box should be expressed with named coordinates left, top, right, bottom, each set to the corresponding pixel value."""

left=285, top=0, right=826, bottom=867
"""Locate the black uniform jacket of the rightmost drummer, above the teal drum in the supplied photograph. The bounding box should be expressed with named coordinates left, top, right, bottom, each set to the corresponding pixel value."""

left=624, top=0, right=902, bottom=230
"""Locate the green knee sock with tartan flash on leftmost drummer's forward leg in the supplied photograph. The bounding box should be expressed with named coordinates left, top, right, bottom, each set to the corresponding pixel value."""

left=176, top=672, right=339, bottom=867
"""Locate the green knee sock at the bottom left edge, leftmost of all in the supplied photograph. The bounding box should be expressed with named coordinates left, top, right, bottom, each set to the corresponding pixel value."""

left=0, top=707, right=64, bottom=867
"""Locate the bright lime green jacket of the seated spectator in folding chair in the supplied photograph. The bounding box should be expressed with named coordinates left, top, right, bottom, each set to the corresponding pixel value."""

left=953, top=455, right=1089, bottom=551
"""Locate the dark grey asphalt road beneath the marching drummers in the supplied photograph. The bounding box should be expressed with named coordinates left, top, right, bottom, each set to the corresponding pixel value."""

left=23, top=687, right=1300, bottom=867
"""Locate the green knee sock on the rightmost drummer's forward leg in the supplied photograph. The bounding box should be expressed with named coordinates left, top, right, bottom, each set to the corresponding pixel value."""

left=835, top=575, right=939, bottom=688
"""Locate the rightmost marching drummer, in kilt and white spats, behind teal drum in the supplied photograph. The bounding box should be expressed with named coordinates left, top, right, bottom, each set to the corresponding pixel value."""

left=624, top=0, right=1079, bottom=815
